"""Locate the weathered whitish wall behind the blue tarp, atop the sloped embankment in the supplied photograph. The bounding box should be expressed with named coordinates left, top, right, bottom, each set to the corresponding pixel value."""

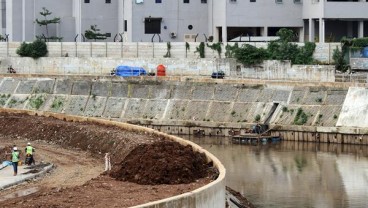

left=0, top=57, right=335, bottom=82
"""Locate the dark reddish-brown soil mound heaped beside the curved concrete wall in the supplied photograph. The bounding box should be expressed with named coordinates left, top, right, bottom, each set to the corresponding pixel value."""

left=110, top=141, right=218, bottom=185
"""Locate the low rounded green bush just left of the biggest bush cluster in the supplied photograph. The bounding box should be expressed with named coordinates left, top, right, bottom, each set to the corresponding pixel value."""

left=234, top=44, right=267, bottom=66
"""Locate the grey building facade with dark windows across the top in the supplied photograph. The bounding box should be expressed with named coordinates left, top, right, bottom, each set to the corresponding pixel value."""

left=0, top=0, right=368, bottom=42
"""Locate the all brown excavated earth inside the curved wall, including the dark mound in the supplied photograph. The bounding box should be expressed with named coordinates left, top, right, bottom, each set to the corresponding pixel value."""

left=0, top=113, right=217, bottom=207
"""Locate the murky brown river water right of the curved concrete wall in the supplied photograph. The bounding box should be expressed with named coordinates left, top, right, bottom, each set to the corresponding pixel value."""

left=187, top=137, right=368, bottom=208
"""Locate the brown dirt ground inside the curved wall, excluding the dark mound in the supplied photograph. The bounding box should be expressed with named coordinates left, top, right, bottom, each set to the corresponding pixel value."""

left=0, top=114, right=215, bottom=207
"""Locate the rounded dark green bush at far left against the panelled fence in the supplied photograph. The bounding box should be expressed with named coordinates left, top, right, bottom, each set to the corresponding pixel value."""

left=16, top=39, right=48, bottom=59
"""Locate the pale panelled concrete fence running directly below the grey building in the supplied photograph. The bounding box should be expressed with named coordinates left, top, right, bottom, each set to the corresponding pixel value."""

left=0, top=42, right=340, bottom=64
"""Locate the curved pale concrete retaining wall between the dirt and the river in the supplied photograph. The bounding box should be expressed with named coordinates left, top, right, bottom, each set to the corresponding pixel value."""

left=0, top=109, right=226, bottom=208
